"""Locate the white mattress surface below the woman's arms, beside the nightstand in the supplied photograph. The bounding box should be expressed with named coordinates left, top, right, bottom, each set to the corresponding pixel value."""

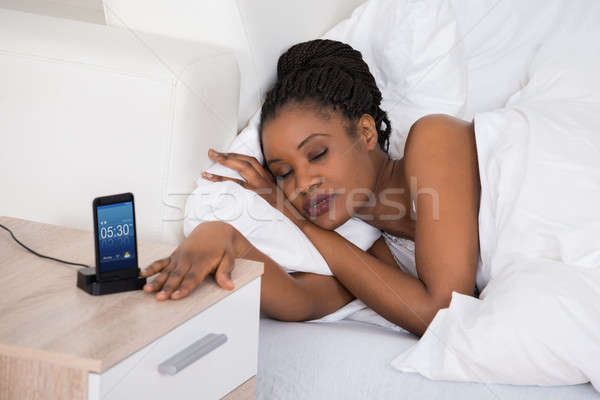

left=256, top=317, right=600, bottom=400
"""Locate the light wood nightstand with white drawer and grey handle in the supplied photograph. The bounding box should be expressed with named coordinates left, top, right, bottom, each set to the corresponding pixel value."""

left=0, top=217, right=263, bottom=400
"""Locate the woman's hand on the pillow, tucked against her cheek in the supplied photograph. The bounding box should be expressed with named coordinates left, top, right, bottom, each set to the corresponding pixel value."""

left=202, top=149, right=305, bottom=226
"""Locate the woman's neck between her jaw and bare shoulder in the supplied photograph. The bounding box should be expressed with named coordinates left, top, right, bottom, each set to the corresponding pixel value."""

left=355, top=153, right=416, bottom=240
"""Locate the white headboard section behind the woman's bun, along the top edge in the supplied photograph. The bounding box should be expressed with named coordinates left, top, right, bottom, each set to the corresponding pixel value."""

left=104, top=0, right=365, bottom=131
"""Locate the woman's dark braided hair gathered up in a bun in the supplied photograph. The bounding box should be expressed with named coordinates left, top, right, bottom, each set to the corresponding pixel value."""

left=259, top=39, right=392, bottom=152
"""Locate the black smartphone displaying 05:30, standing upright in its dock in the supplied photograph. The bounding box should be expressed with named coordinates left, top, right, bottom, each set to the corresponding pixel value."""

left=93, top=193, right=140, bottom=282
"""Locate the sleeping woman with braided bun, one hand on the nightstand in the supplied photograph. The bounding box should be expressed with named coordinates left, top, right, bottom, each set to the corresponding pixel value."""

left=142, top=40, right=480, bottom=336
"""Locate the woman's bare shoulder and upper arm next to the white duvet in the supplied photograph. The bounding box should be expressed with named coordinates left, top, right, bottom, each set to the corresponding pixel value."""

left=404, top=114, right=480, bottom=293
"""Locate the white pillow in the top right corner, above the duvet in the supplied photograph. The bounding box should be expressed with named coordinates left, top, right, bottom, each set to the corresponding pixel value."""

left=452, top=0, right=600, bottom=120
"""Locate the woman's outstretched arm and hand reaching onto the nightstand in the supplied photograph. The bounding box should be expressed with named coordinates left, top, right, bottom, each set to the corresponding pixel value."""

left=141, top=221, right=354, bottom=321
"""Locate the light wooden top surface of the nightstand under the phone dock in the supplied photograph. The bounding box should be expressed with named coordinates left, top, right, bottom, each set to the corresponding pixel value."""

left=0, top=216, right=263, bottom=372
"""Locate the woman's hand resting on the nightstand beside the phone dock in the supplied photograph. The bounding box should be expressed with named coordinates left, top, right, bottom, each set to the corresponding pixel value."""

left=141, top=221, right=239, bottom=300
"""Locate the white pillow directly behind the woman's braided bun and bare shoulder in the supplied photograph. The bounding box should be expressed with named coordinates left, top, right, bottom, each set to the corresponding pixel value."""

left=323, top=0, right=467, bottom=158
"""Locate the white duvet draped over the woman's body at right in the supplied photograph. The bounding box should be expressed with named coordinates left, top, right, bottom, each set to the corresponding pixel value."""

left=392, top=30, right=600, bottom=390
